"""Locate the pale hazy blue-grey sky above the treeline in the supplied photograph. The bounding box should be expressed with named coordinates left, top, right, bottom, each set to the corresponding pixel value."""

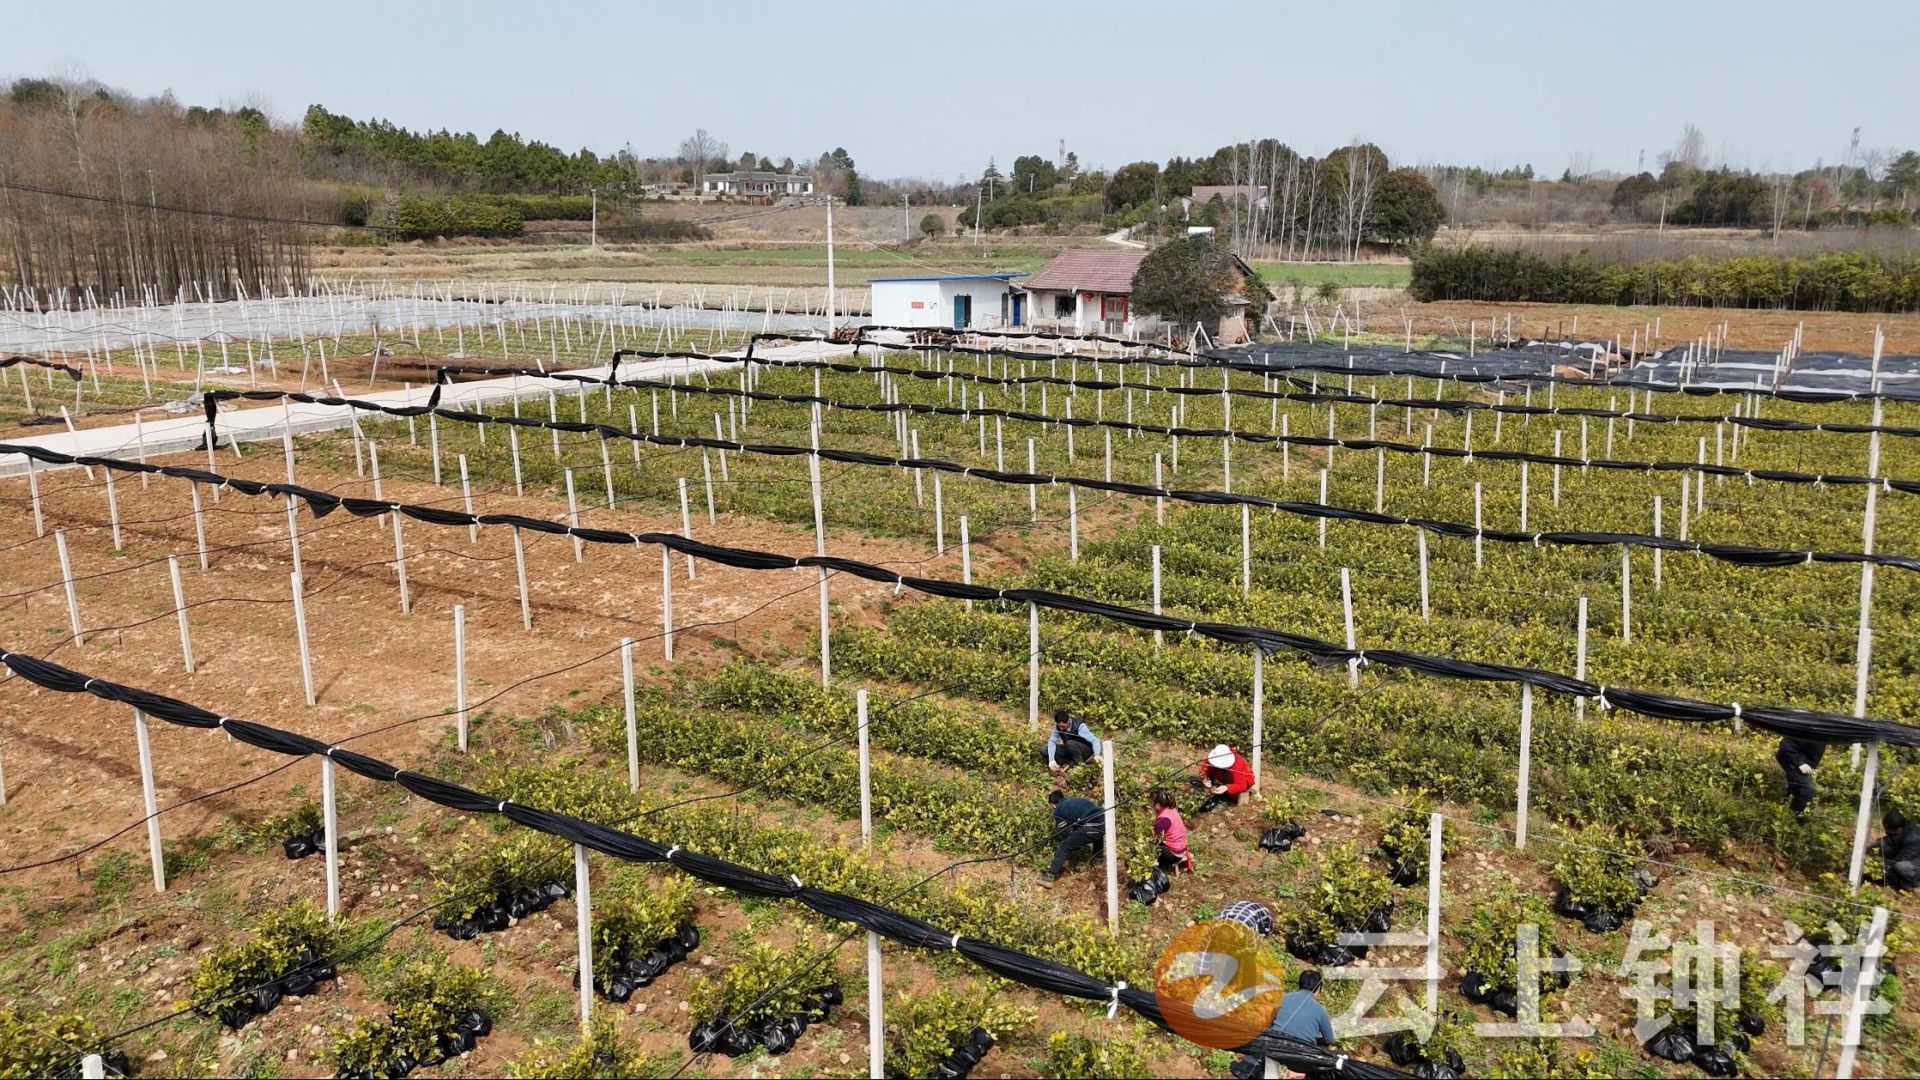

left=0, top=0, right=1920, bottom=179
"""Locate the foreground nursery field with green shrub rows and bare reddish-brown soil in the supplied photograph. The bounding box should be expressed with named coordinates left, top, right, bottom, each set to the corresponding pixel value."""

left=0, top=313, right=1920, bottom=1076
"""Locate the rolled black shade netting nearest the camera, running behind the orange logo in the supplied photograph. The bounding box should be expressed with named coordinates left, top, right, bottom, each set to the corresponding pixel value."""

left=0, top=648, right=1404, bottom=1080
